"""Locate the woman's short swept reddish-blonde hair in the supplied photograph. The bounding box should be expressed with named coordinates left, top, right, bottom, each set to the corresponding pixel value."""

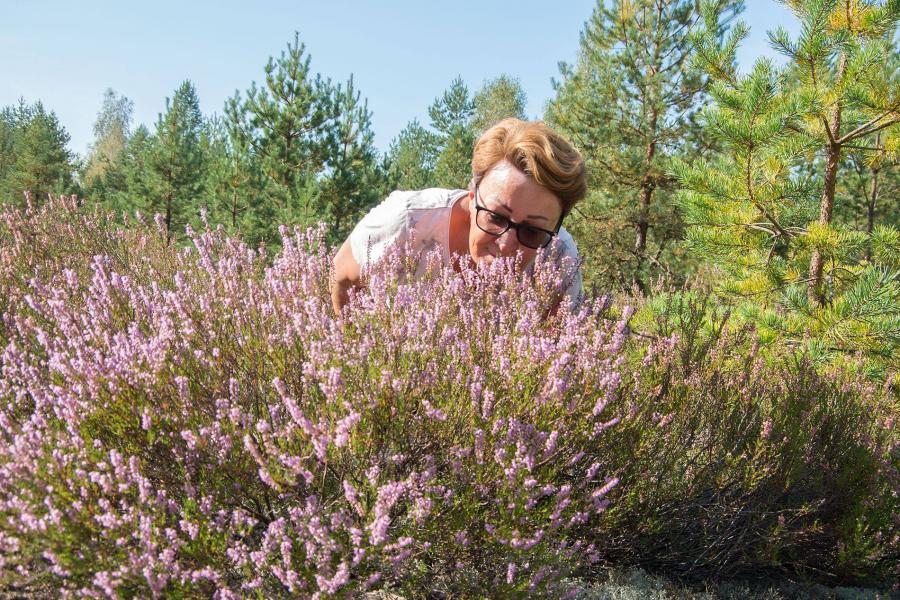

left=469, top=118, right=587, bottom=216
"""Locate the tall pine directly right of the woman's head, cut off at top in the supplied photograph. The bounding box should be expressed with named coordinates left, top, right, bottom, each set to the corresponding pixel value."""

left=546, top=0, right=742, bottom=291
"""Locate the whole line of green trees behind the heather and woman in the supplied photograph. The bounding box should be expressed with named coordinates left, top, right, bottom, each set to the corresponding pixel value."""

left=0, top=0, right=900, bottom=370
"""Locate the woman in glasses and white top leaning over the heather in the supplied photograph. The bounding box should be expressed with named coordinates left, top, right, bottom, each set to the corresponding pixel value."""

left=331, top=119, right=587, bottom=314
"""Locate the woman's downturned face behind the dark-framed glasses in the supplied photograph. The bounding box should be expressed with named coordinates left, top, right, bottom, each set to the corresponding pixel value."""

left=469, top=160, right=562, bottom=266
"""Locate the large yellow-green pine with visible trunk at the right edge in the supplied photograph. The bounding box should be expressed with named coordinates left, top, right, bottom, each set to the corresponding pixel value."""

left=673, top=0, right=900, bottom=367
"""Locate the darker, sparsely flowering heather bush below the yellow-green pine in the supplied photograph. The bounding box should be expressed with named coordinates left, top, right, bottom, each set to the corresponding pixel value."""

left=599, top=291, right=900, bottom=582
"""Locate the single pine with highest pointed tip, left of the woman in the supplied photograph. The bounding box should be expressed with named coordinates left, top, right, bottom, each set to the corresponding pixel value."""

left=225, top=33, right=336, bottom=226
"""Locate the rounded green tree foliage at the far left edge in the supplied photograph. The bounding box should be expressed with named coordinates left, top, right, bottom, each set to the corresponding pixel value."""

left=0, top=100, right=76, bottom=204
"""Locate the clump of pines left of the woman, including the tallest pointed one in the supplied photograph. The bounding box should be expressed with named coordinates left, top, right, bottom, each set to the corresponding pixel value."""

left=217, top=34, right=387, bottom=245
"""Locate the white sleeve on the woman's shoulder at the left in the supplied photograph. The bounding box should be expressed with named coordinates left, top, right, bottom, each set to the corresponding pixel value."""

left=349, top=191, right=409, bottom=272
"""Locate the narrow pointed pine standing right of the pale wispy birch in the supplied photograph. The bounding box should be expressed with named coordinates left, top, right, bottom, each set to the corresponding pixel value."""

left=145, top=81, right=206, bottom=238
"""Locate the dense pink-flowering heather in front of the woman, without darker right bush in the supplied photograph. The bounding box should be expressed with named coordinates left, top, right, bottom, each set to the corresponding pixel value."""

left=0, top=199, right=625, bottom=598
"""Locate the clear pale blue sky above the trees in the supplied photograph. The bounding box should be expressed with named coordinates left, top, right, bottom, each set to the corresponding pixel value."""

left=0, top=0, right=797, bottom=155
